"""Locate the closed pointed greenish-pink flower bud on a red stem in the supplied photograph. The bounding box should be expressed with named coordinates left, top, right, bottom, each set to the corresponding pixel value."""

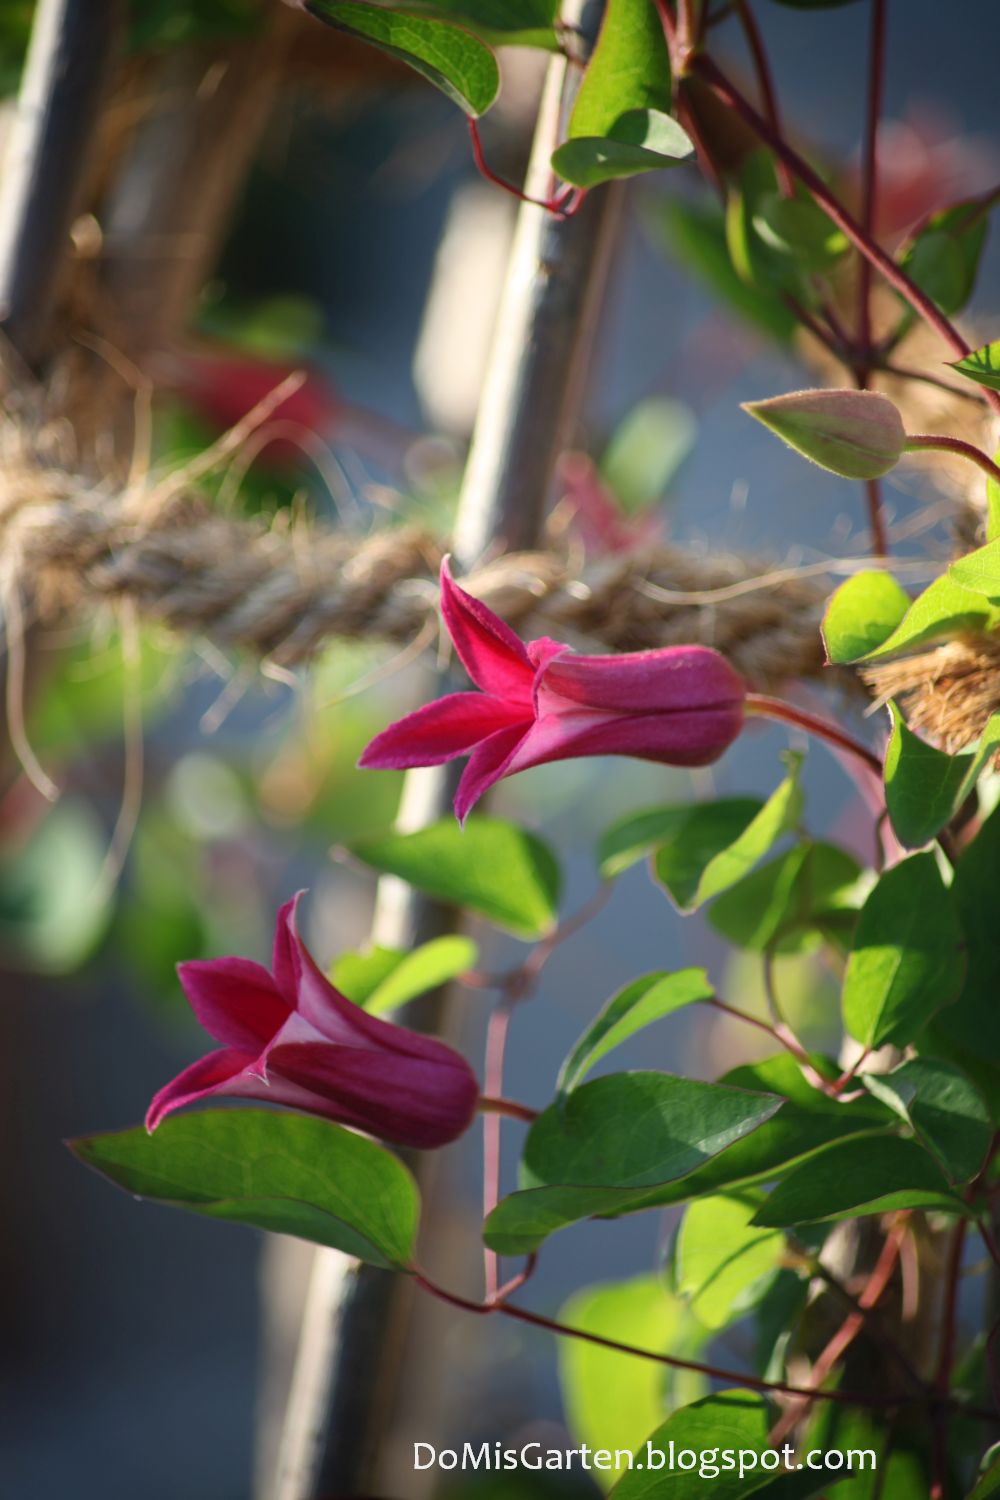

left=742, top=390, right=906, bottom=479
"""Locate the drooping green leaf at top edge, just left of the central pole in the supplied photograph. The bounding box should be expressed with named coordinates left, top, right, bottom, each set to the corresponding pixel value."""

left=304, top=0, right=499, bottom=116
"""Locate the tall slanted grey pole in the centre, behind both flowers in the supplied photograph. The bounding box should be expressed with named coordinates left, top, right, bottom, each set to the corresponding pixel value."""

left=268, top=3, right=619, bottom=1500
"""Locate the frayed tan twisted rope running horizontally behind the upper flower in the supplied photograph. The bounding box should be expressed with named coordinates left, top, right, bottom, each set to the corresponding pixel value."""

left=0, top=468, right=828, bottom=689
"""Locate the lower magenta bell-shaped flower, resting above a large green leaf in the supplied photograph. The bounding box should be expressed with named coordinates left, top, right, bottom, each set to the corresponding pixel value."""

left=145, top=897, right=478, bottom=1146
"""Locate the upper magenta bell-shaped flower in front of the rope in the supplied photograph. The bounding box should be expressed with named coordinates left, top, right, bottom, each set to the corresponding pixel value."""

left=358, top=558, right=747, bottom=822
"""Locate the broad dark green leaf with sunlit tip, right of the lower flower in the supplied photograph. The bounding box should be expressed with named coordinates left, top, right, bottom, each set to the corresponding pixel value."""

left=525, top=1073, right=784, bottom=1188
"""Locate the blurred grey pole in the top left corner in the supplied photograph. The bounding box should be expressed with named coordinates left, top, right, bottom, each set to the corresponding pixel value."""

left=0, top=0, right=124, bottom=369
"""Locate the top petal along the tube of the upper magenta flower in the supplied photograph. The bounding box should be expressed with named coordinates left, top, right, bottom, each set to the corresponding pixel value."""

left=537, top=647, right=747, bottom=714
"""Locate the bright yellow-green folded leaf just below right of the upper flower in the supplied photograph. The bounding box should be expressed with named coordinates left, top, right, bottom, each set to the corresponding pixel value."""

left=654, top=756, right=802, bottom=912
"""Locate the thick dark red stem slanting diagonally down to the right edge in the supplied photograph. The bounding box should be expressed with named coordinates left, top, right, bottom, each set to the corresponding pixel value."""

left=688, top=53, right=1000, bottom=411
